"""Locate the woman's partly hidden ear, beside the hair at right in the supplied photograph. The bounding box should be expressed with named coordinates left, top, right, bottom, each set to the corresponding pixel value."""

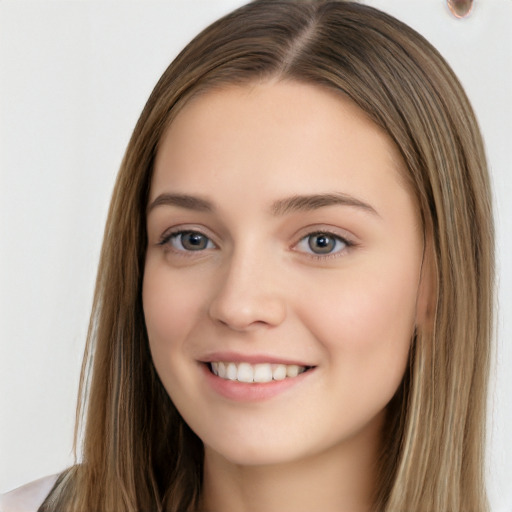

left=416, top=237, right=438, bottom=331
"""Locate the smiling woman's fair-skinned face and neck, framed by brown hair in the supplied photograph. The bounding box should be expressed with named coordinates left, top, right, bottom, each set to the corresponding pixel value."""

left=143, top=80, right=426, bottom=512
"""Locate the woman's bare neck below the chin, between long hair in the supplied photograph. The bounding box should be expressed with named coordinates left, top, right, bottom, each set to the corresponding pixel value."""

left=200, top=416, right=380, bottom=512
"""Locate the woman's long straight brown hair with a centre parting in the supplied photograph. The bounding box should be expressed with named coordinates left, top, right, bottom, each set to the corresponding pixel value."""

left=41, top=0, right=494, bottom=512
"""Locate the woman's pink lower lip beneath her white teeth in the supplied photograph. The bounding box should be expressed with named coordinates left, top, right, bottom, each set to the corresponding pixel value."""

left=201, top=363, right=314, bottom=402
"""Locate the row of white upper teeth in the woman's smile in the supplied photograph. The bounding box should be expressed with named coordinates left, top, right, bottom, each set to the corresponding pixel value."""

left=211, top=361, right=306, bottom=383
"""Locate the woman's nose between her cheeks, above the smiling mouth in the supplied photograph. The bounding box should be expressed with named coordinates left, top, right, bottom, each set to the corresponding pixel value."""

left=209, top=251, right=286, bottom=331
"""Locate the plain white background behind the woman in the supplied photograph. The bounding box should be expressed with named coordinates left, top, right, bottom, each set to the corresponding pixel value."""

left=0, top=0, right=512, bottom=512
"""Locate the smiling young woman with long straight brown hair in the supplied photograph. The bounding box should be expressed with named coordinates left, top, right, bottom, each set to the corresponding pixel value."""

left=1, top=0, right=493, bottom=512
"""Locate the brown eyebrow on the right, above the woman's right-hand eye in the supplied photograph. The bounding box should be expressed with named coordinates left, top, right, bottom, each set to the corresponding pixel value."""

left=271, top=192, right=380, bottom=217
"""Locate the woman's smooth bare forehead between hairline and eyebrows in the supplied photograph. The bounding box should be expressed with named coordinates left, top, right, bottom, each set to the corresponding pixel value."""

left=150, top=81, right=414, bottom=218
